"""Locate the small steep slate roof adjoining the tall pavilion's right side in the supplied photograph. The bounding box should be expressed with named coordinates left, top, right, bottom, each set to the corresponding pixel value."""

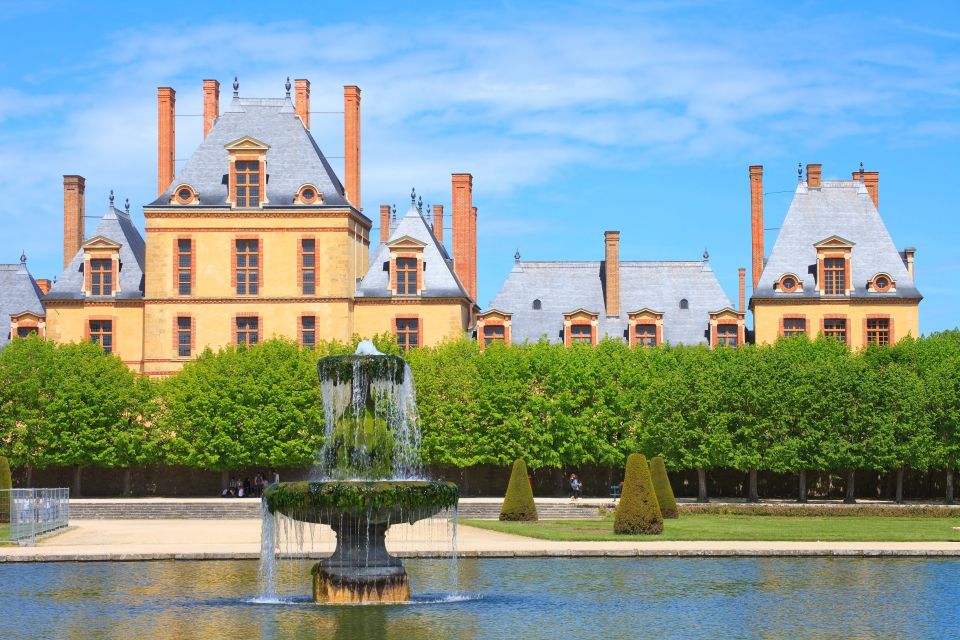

left=356, top=206, right=470, bottom=299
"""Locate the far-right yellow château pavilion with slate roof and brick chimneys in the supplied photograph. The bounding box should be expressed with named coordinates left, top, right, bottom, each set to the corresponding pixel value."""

left=750, top=164, right=923, bottom=348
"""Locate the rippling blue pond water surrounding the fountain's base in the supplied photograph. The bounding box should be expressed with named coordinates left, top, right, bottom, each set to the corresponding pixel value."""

left=0, top=558, right=960, bottom=640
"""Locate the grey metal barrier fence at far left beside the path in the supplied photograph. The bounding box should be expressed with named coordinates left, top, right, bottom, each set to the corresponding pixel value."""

left=0, top=489, right=70, bottom=546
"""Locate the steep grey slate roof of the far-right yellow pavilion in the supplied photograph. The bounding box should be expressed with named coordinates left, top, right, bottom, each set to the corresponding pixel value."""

left=753, top=180, right=922, bottom=300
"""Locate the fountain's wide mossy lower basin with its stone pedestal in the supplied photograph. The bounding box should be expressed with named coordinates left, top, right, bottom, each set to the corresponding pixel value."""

left=263, top=480, right=460, bottom=604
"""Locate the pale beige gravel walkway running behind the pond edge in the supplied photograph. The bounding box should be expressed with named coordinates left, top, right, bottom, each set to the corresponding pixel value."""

left=0, top=519, right=960, bottom=562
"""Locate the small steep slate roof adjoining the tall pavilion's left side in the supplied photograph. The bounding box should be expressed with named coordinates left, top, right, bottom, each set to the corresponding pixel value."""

left=46, top=204, right=146, bottom=300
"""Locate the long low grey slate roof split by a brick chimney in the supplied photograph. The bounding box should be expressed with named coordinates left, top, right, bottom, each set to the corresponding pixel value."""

left=490, top=260, right=733, bottom=345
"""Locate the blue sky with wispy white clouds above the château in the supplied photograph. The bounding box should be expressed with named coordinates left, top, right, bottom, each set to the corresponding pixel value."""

left=0, top=0, right=960, bottom=333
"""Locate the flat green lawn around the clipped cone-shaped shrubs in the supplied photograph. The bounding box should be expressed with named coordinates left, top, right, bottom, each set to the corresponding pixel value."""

left=461, top=514, right=960, bottom=542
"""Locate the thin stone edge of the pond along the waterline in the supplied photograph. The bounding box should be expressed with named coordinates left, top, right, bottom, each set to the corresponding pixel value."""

left=0, top=546, right=960, bottom=565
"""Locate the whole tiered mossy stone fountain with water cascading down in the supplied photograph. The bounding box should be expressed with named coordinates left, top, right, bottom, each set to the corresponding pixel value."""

left=263, top=341, right=459, bottom=604
